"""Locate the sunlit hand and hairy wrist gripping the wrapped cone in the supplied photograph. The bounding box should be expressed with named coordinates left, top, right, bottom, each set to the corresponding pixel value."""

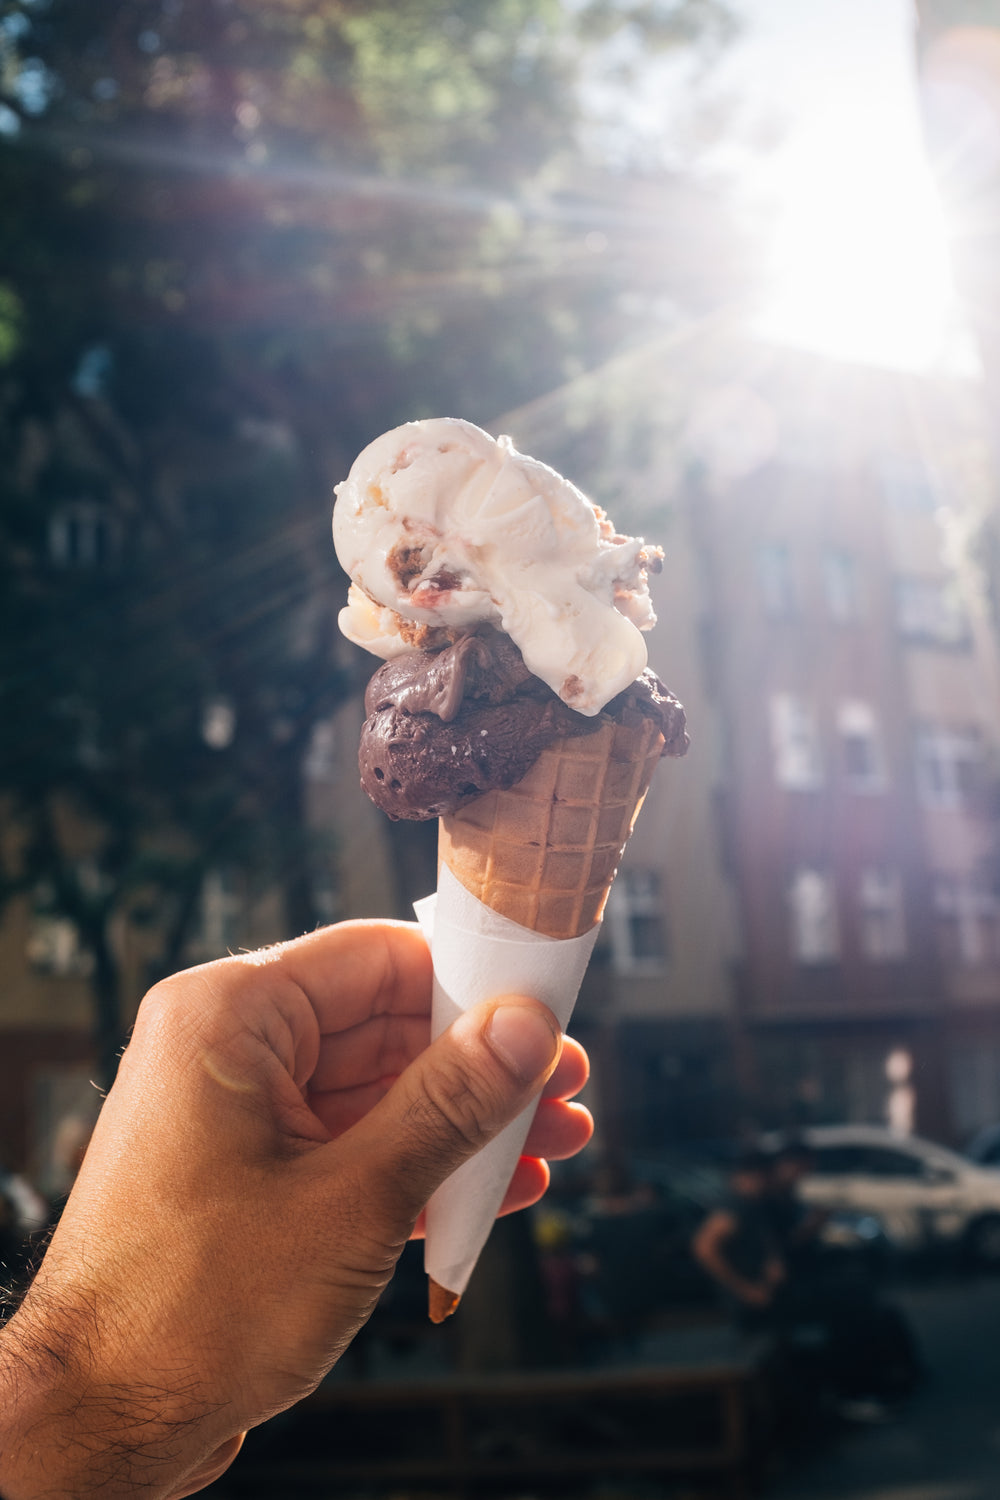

left=0, top=923, right=592, bottom=1500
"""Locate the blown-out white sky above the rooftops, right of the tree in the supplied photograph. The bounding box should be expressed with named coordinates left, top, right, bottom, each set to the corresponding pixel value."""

left=714, top=0, right=973, bottom=374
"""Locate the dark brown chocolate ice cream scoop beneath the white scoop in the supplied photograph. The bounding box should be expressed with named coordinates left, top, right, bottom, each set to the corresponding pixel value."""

left=358, top=629, right=687, bottom=819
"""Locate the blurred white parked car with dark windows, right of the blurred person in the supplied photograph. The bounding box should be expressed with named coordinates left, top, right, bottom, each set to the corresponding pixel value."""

left=801, top=1125, right=1000, bottom=1269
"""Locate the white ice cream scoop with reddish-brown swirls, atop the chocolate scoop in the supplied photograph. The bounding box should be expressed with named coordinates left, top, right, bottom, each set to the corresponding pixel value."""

left=333, top=417, right=661, bottom=716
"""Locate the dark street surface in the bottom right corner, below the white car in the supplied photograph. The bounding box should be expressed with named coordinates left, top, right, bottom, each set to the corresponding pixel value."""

left=766, top=1278, right=1000, bottom=1500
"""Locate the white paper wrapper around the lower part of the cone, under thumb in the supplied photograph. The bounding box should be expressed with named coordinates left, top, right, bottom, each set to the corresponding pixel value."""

left=414, top=866, right=600, bottom=1295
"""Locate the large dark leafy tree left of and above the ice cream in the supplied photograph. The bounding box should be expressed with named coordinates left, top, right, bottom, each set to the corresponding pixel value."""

left=0, top=0, right=743, bottom=1074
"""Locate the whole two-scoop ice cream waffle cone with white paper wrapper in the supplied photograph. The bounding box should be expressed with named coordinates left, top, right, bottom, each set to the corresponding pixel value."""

left=333, top=417, right=687, bottom=1322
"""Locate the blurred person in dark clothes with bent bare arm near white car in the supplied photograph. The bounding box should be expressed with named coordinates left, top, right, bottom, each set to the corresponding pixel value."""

left=691, top=1148, right=787, bottom=1332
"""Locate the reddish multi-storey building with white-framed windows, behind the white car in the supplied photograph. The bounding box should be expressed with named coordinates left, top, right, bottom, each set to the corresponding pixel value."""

left=671, top=345, right=1000, bottom=1139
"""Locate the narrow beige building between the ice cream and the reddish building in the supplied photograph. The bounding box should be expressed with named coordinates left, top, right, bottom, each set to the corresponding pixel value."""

left=574, top=468, right=741, bottom=1151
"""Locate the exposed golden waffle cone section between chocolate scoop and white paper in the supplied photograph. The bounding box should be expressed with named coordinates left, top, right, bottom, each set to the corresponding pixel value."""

left=438, top=719, right=664, bottom=938
